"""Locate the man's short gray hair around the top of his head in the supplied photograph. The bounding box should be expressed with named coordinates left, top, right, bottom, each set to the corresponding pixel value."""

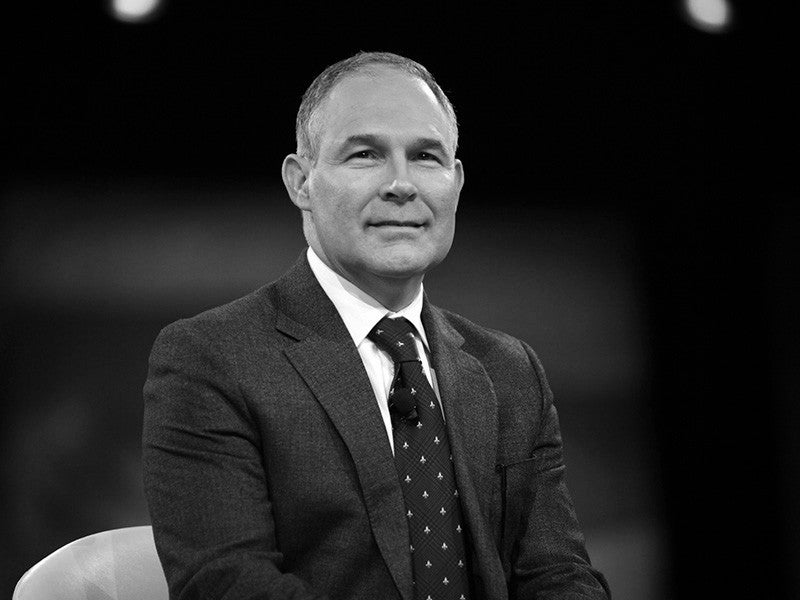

left=296, top=52, right=458, bottom=160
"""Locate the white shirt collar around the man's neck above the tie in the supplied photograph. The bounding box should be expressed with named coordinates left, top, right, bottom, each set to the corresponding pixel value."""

left=306, top=246, right=430, bottom=350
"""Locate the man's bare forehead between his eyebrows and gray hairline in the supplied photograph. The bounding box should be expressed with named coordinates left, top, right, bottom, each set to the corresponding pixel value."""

left=315, top=65, right=453, bottom=147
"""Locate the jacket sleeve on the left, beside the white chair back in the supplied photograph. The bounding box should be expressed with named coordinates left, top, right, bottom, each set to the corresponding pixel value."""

left=143, top=321, right=323, bottom=600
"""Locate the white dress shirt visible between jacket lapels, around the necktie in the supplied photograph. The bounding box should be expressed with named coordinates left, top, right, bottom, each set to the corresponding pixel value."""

left=307, top=247, right=441, bottom=453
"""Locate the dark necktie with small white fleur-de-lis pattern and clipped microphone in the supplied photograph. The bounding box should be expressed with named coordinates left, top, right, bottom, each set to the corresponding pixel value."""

left=368, top=317, right=469, bottom=600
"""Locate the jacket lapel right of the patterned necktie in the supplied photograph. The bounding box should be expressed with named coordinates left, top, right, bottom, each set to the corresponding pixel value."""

left=422, top=300, right=503, bottom=591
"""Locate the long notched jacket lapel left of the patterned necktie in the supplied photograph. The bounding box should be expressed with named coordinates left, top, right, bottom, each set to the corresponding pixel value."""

left=271, top=255, right=413, bottom=600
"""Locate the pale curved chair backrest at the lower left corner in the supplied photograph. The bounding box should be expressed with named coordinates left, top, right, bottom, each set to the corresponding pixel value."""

left=13, top=526, right=169, bottom=600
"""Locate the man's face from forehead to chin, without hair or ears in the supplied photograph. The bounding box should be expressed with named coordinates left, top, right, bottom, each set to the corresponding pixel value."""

left=294, top=66, right=463, bottom=284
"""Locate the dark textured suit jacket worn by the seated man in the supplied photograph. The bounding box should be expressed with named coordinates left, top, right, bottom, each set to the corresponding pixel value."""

left=144, top=255, right=607, bottom=600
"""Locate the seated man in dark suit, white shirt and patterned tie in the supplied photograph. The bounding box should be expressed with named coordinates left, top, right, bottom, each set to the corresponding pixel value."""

left=144, top=53, right=608, bottom=600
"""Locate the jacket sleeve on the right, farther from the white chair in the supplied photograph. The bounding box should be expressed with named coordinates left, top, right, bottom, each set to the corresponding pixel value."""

left=501, top=344, right=611, bottom=600
